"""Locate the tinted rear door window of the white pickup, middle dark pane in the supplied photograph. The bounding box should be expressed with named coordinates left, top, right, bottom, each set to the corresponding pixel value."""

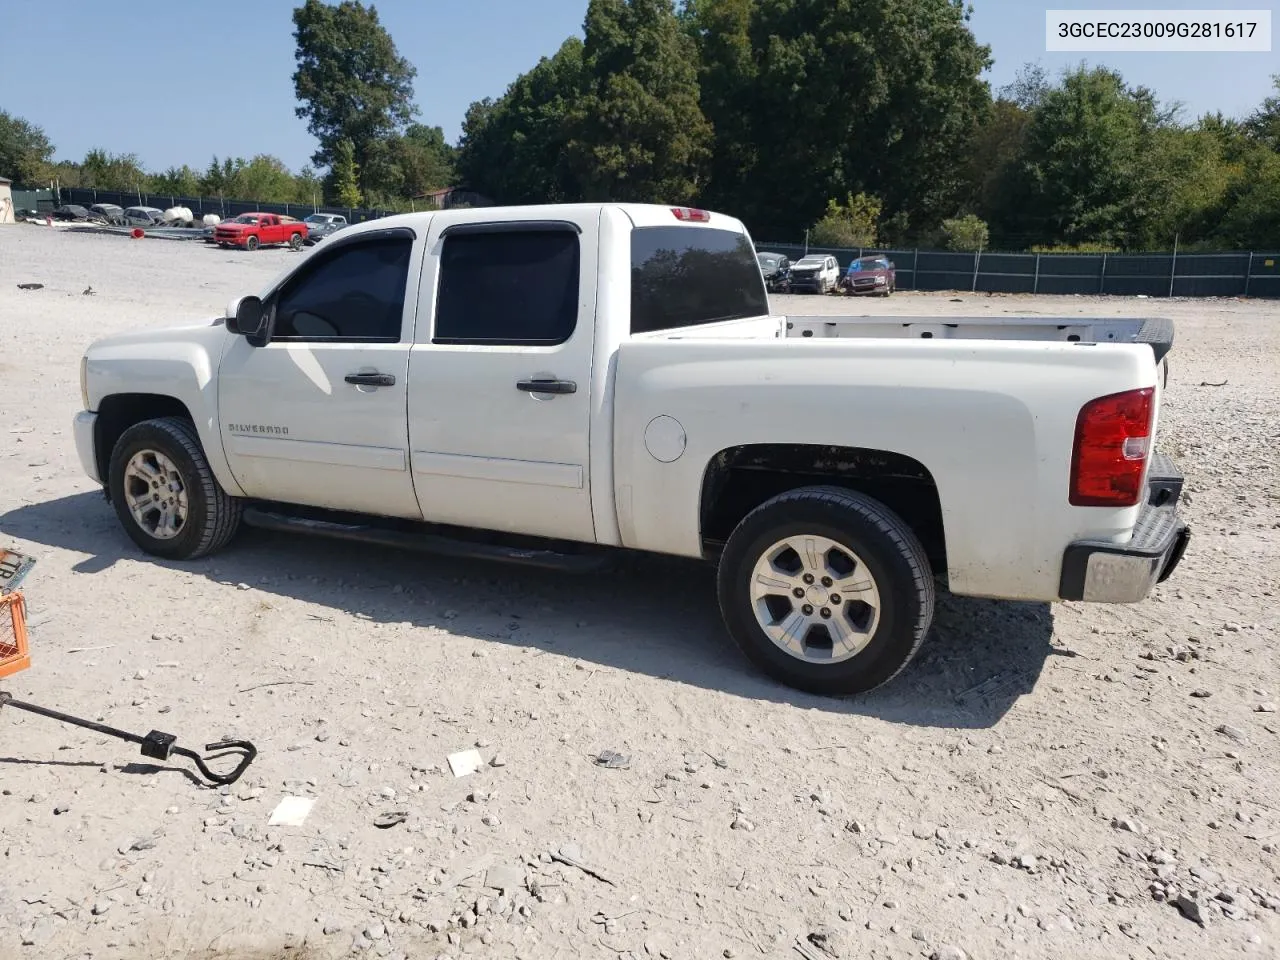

left=435, top=229, right=579, bottom=346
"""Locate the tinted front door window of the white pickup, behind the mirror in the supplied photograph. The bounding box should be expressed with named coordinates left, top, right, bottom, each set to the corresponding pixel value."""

left=271, top=237, right=413, bottom=343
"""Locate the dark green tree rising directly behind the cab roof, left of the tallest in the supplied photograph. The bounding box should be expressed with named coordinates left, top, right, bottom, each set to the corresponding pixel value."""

left=457, top=37, right=586, bottom=204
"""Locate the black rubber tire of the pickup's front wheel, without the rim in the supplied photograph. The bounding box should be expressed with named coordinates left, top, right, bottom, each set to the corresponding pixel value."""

left=108, top=417, right=243, bottom=559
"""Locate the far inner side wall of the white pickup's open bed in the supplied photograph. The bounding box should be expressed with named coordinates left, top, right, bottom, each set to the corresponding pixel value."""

left=786, top=315, right=1174, bottom=364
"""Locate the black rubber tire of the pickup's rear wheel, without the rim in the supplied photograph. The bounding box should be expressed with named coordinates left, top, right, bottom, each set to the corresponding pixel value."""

left=718, top=486, right=934, bottom=696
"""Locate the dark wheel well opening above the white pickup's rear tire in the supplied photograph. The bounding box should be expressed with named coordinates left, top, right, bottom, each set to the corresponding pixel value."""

left=699, top=443, right=947, bottom=572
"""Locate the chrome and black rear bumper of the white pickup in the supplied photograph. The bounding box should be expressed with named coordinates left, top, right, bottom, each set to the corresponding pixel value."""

left=1059, top=454, right=1192, bottom=603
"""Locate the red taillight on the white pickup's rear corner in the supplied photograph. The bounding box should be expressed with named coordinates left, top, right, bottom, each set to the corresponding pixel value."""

left=1070, top=387, right=1156, bottom=507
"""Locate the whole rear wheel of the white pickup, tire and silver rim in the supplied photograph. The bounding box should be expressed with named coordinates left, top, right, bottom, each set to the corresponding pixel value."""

left=718, top=486, right=934, bottom=696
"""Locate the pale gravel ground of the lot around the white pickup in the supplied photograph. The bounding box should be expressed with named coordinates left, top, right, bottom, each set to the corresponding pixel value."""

left=0, top=227, right=1280, bottom=960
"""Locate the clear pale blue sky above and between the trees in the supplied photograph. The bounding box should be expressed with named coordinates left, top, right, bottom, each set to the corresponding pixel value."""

left=0, top=0, right=1280, bottom=170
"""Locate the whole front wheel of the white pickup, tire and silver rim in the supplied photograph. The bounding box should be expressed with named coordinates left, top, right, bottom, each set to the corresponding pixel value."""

left=108, top=417, right=242, bottom=559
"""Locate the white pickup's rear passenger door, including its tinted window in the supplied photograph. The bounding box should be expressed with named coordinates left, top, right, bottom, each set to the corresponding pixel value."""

left=408, top=210, right=599, bottom=541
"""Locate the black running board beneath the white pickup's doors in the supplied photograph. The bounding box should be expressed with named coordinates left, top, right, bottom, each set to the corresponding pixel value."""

left=243, top=507, right=608, bottom=573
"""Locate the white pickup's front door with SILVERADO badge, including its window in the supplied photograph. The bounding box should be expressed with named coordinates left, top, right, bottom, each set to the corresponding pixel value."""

left=218, top=228, right=424, bottom=518
